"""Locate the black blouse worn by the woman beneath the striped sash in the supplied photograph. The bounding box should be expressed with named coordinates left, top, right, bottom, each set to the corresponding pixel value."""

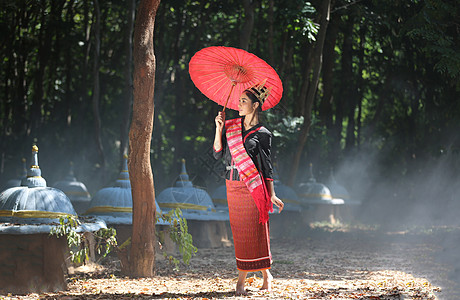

left=213, top=119, right=273, bottom=180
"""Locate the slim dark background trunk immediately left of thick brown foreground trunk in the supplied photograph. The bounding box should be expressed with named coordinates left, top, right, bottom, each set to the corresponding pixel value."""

left=120, top=0, right=136, bottom=166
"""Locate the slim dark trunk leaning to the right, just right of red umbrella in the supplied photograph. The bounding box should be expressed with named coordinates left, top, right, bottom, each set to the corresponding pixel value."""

left=288, top=0, right=331, bottom=186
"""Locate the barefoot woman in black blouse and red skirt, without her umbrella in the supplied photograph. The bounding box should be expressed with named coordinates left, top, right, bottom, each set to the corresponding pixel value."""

left=214, top=83, right=284, bottom=295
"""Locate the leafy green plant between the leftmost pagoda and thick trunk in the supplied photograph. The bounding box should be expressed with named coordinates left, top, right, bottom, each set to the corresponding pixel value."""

left=50, top=215, right=117, bottom=264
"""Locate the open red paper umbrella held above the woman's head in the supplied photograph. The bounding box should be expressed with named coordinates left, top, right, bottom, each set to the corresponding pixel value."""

left=189, top=46, right=283, bottom=110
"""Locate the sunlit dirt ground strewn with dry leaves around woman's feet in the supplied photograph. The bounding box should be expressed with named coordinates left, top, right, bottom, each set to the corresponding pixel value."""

left=0, top=228, right=460, bottom=300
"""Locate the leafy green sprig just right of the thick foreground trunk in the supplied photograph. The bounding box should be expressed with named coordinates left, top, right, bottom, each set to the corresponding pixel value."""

left=157, top=208, right=198, bottom=270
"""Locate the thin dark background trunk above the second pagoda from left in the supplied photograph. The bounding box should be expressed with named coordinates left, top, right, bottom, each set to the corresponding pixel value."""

left=92, top=0, right=105, bottom=174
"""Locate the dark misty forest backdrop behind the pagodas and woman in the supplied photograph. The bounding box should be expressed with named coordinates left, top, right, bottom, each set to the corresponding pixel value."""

left=0, top=0, right=460, bottom=224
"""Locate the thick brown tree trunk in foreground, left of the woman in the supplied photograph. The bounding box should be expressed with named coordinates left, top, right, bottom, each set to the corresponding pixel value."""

left=128, top=0, right=160, bottom=277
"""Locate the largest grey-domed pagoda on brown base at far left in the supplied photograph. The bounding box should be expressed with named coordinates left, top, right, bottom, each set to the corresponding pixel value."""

left=0, top=145, right=106, bottom=294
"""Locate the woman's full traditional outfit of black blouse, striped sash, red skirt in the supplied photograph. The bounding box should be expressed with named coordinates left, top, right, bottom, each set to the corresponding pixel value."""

left=214, top=118, right=273, bottom=271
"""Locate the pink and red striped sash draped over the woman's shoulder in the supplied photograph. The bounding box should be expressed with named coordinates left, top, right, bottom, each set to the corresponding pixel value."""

left=225, top=118, right=273, bottom=223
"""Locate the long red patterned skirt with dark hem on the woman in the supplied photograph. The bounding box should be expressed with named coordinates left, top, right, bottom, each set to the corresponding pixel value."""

left=226, top=180, right=272, bottom=271
